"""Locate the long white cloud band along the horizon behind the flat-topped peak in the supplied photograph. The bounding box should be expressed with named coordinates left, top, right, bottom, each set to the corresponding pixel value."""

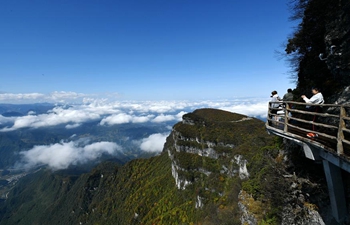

left=0, top=94, right=268, bottom=132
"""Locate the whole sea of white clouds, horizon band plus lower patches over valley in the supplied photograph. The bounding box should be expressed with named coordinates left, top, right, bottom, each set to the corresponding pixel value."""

left=0, top=92, right=269, bottom=169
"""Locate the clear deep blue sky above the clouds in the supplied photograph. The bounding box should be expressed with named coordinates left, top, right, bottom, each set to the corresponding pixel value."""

left=0, top=0, right=295, bottom=103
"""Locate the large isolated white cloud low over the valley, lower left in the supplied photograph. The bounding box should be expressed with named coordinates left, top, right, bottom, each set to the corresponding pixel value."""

left=20, top=141, right=121, bottom=170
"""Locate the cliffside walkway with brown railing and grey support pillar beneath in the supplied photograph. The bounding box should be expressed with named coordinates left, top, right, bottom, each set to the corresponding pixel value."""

left=266, top=101, right=350, bottom=223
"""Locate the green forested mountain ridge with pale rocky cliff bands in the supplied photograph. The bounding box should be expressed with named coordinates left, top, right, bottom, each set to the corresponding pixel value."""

left=0, top=109, right=330, bottom=225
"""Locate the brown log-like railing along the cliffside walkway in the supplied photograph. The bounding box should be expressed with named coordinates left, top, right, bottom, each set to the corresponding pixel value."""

left=266, top=101, right=350, bottom=157
